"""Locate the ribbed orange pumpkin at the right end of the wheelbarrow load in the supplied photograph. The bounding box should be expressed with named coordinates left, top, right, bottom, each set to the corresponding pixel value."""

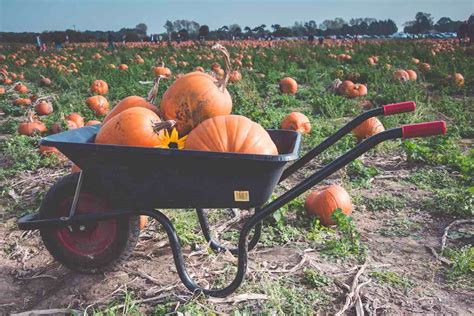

left=184, top=115, right=278, bottom=155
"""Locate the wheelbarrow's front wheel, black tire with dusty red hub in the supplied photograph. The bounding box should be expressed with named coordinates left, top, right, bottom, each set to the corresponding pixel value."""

left=39, top=173, right=140, bottom=273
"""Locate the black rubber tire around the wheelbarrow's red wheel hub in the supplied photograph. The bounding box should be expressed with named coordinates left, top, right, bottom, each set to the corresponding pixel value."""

left=39, top=173, right=140, bottom=274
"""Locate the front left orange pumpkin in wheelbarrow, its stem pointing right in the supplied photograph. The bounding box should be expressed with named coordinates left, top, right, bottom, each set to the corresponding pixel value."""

left=95, top=107, right=171, bottom=147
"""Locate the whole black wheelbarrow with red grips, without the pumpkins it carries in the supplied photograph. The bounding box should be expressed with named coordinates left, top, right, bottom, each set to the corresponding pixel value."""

left=18, top=102, right=446, bottom=297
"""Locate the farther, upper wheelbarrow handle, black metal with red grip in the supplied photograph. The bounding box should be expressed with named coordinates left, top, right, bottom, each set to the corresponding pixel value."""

left=280, top=101, right=416, bottom=182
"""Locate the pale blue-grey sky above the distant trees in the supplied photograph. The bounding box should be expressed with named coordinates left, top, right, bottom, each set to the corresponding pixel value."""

left=0, top=0, right=474, bottom=33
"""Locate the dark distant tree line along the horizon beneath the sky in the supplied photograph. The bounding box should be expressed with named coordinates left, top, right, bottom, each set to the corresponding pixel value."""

left=0, top=12, right=463, bottom=43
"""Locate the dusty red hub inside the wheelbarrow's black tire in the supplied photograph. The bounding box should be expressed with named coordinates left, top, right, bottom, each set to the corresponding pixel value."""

left=56, top=193, right=117, bottom=257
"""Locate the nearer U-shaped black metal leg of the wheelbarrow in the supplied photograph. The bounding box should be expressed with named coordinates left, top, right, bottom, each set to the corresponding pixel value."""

left=140, top=210, right=263, bottom=297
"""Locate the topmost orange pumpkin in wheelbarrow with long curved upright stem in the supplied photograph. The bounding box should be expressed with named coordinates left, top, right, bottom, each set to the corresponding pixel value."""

left=161, top=44, right=232, bottom=135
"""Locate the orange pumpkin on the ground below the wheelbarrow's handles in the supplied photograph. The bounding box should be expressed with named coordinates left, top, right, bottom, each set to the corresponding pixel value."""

left=305, top=184, right=352, bottom=226
